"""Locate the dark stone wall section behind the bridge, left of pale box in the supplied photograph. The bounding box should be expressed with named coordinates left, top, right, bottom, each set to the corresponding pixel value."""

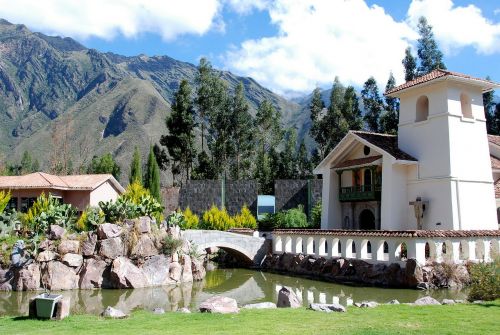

left=178, top=180, right=259, bottom=215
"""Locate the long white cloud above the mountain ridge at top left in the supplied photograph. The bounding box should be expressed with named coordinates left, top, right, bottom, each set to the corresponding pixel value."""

left=0, top=0, right=223, bottom=40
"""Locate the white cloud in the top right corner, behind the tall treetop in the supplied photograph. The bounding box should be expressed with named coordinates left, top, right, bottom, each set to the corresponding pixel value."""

left=408, top=0, right=500, bottom=54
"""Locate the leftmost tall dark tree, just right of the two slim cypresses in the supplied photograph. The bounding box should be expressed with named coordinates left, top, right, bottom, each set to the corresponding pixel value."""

left=162, top=79, right=196, bottom=185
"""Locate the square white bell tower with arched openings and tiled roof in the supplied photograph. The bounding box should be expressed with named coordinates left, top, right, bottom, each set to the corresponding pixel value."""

left=386, top=69, right=499, bottom=230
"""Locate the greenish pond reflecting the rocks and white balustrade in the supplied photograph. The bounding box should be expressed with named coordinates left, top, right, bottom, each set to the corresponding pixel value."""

left=0, top=269, right=467, bottom=315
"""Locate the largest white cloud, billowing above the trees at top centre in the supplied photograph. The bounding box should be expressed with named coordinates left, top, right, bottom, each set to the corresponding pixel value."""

left=225, top=0, right=417, bottom=95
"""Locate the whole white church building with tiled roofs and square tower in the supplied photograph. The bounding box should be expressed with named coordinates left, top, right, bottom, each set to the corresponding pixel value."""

left=314, top=70, right=500, bottom=234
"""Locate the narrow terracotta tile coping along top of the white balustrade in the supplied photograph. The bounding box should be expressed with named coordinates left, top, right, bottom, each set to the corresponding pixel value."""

left=273, top=229, right=500, bottom=238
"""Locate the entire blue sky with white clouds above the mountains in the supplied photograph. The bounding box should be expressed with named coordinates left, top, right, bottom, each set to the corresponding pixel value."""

left=0, top=0, right=500, bottom=96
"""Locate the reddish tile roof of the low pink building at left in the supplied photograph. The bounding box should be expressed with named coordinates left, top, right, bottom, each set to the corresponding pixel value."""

left=0, top=172, right=123, bottom=192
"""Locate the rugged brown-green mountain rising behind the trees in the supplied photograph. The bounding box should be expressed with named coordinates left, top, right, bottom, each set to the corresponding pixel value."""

left=0, top=19, right=309, bottom=185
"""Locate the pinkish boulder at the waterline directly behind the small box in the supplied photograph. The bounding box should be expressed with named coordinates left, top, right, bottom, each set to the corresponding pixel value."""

left=41, top=261, right=80, bottom=291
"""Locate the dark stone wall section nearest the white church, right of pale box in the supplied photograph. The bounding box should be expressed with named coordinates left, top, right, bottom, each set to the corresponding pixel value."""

left=274, top=179, right=322, bottom=217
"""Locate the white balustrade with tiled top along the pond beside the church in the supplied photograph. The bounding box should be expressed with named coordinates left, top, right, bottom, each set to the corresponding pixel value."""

left=273, top=229, right=500, bottom=264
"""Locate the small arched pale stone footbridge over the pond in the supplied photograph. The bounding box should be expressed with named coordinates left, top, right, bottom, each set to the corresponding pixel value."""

left=182, top=230, right=271, bottom=266
